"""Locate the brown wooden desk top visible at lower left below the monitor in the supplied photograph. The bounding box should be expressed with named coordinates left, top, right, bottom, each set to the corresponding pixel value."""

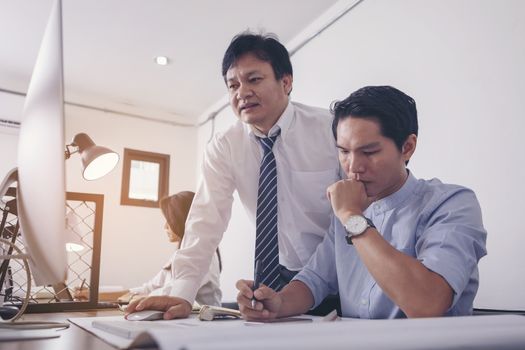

left=0, top=309, right=122, bottom=350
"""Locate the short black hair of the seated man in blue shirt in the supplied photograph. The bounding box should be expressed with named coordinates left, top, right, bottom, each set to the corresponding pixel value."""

left=330, top=86, right=418, bottom=151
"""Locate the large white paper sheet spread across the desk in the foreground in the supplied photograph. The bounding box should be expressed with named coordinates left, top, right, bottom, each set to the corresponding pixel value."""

left=70, top=315, right=525, bottom=350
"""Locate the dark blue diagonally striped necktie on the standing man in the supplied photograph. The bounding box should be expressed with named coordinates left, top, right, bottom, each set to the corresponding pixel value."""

left=255, top=132, right=280, bottom=290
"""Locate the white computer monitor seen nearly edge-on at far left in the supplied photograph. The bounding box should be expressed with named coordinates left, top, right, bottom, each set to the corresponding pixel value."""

left=0, top=0, right=67, bottom=285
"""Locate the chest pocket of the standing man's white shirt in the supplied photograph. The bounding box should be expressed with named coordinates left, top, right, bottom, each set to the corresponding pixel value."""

left=291, top=169, right=338, bottom=215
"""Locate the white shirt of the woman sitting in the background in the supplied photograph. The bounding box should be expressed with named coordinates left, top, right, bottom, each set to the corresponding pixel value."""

left=129, top=243, right=222, bottom=306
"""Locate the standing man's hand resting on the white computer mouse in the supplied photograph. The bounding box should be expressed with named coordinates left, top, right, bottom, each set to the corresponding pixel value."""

left=126, top=296, right=191, bottom=320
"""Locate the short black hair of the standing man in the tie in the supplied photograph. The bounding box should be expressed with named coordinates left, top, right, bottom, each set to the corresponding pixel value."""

left=222, top=32, right=293, bottom=81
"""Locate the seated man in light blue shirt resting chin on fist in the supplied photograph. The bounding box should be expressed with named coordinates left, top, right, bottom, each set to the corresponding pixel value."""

left=237, top=86, right=486, bottom=320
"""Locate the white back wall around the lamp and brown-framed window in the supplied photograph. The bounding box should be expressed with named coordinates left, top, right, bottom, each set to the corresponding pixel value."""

left=0, top=94, right=197, bottom=287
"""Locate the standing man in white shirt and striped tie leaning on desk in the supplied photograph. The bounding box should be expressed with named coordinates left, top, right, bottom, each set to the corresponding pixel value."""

left=128, top=34, right=340, bottom=319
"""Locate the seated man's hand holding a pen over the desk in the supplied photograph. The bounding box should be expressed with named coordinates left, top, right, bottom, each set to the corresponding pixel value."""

left=235, top=280, right=282, bottom=321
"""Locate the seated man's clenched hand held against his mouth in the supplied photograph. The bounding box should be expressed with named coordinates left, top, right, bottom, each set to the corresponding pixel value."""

left=326, top=179, right=374, bottom=222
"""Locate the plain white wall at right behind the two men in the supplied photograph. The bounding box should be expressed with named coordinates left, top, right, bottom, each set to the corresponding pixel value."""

left=195, top=0, right=525, bottom=309
